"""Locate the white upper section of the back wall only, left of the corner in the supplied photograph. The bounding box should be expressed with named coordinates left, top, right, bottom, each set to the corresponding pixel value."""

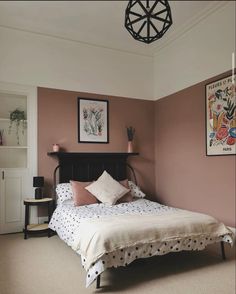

left=0, top=27, right=153, bottom=99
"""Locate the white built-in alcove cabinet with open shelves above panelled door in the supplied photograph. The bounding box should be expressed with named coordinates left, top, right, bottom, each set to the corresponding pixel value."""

left=0, top=83, right=37, bottom=234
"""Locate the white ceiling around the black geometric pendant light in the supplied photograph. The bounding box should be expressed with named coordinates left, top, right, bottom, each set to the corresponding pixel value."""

left=0, top=1, right=227, bottom=56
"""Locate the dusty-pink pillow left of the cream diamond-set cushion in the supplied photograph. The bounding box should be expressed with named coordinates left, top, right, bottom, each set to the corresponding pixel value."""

left=70, top=181, right=98, bottom=206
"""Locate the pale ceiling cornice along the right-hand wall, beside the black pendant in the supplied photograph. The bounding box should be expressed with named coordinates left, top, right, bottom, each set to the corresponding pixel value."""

left=153, top=1, right=231, bottom=56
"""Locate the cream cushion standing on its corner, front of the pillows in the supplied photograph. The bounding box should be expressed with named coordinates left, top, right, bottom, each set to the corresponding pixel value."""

left=85, top=171, right=129, bottom=205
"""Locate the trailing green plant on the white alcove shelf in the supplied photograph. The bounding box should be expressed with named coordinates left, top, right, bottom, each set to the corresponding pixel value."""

left=9, top=108, right=27, bottom=145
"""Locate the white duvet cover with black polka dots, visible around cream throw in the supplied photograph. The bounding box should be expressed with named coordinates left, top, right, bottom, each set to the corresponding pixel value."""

left=49, top=198, right=232, bottom=287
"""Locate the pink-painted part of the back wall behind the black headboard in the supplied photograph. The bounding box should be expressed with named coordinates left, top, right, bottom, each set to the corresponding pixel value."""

left=38, top=88, right=155, bottom=198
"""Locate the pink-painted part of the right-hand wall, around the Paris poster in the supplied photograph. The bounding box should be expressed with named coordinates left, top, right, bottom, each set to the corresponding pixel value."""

left=155, top=72, right=236, bottom=227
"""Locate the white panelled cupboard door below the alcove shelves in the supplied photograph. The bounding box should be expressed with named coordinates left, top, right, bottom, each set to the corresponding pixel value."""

left=0, top=169, right=24, bottom=234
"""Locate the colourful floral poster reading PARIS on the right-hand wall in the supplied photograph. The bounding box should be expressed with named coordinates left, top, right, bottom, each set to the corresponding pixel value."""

left=206, top=76, right=236, bottom=155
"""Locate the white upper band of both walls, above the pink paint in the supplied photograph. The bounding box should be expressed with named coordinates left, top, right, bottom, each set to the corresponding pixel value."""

left=0, top=1, right=235, bottom=100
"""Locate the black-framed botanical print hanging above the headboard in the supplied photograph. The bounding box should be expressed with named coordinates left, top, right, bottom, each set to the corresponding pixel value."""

left=78, top=97, right=109, bottom=144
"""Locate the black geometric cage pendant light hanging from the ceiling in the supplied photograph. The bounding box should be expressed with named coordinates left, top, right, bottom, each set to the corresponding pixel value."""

left=125, top=0, right=172, bottom=44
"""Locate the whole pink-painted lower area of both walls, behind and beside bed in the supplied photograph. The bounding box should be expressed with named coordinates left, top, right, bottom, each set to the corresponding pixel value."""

left=38, top=73, right=235, bottom=226
